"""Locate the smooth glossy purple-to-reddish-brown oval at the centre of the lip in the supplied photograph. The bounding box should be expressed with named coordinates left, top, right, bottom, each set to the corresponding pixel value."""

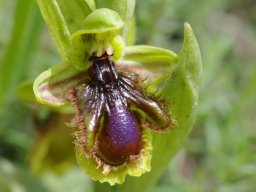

left=98, top=101, right=141, bottom=165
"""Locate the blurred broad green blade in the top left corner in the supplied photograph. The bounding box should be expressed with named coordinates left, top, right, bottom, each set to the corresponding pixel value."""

left=0, top=0, right=43, bottom=114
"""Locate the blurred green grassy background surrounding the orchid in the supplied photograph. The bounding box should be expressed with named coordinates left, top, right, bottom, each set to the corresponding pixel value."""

left=0, top=0, right=256, bottom=192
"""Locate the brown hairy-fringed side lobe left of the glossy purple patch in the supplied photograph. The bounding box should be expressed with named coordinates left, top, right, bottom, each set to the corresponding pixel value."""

left=68, top=84, right=105, bottom=152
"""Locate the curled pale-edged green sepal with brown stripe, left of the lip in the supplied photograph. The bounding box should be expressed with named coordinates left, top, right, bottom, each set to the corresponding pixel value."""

left=33, top=63, right=88, bottom=107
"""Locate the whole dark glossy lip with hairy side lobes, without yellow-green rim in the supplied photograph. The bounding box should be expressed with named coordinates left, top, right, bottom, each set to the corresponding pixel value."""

left=68, top=53, right=173, bottom=166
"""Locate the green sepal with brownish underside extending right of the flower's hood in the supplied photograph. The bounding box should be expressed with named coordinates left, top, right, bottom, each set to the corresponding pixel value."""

left=117, top=45, right=179, bottom=84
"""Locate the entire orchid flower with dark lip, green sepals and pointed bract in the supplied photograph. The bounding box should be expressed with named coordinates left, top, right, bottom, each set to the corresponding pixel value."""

left=33, top=0, right=201, bottom=185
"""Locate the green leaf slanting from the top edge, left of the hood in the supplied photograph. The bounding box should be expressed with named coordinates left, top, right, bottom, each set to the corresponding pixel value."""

left=37, top=0, right=93, bottom=59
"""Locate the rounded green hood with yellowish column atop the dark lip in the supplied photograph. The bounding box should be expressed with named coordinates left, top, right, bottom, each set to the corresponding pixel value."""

left=68, top=8, right=124, bottom=70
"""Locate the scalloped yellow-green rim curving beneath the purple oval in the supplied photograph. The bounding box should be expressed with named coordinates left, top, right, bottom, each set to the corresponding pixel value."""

left=75, top=127, right=152, bottom=185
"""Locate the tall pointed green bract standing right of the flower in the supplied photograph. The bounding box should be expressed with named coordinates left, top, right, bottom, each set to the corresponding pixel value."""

left=95, top=24, right=202, bottom=192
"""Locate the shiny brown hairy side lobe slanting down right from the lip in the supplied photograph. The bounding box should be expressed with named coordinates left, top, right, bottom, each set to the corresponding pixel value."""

left=117, top=75, right=176, bottom=131
